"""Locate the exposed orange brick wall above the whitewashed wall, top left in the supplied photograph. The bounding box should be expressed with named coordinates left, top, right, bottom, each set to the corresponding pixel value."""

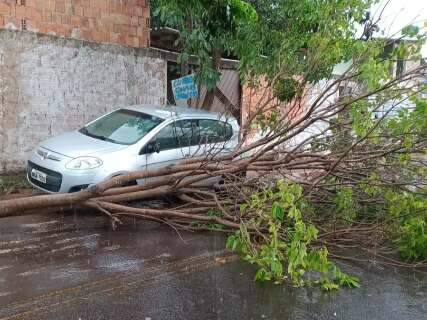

left=0, top=0, right=150, bottom=47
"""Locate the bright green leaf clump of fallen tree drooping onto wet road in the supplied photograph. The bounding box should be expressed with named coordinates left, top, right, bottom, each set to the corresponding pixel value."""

left=227, top=181, right=359, bottom=290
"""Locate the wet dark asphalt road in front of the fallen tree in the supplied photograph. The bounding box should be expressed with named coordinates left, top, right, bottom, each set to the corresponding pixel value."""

left=0, top=210, right=427, bottom=320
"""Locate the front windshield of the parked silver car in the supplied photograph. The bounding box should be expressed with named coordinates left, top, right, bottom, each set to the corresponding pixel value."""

left=79, top=109, right=163, bottom=145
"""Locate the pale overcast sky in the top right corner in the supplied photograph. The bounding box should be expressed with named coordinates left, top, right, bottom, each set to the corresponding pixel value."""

left=372, top=0, right=427, bottom=57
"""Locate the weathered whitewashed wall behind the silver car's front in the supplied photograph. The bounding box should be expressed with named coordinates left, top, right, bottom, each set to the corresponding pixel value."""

left=0, top=30, right=167, bottom=173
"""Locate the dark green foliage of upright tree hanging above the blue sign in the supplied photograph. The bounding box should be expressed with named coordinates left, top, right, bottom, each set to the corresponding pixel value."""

left=152, top=0, right=258, bottom=89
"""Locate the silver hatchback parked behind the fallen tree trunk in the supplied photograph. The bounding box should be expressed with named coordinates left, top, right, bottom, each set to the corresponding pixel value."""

left=27, top=105, right=239, bottom=193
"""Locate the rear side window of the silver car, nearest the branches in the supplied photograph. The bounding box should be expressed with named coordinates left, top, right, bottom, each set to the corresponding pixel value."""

left=199, top=120, right=233, bottom=144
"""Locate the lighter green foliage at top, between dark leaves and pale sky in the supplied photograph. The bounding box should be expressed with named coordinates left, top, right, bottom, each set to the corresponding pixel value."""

left=236, top=0, right=371, bottom=83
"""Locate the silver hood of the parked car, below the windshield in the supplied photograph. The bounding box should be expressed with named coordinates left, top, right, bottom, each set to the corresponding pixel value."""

left=40, top=131, right=128, bottom=158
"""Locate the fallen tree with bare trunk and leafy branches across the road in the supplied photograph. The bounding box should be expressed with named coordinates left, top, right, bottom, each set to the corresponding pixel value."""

left=0, top=61, right=427, bottom=289
